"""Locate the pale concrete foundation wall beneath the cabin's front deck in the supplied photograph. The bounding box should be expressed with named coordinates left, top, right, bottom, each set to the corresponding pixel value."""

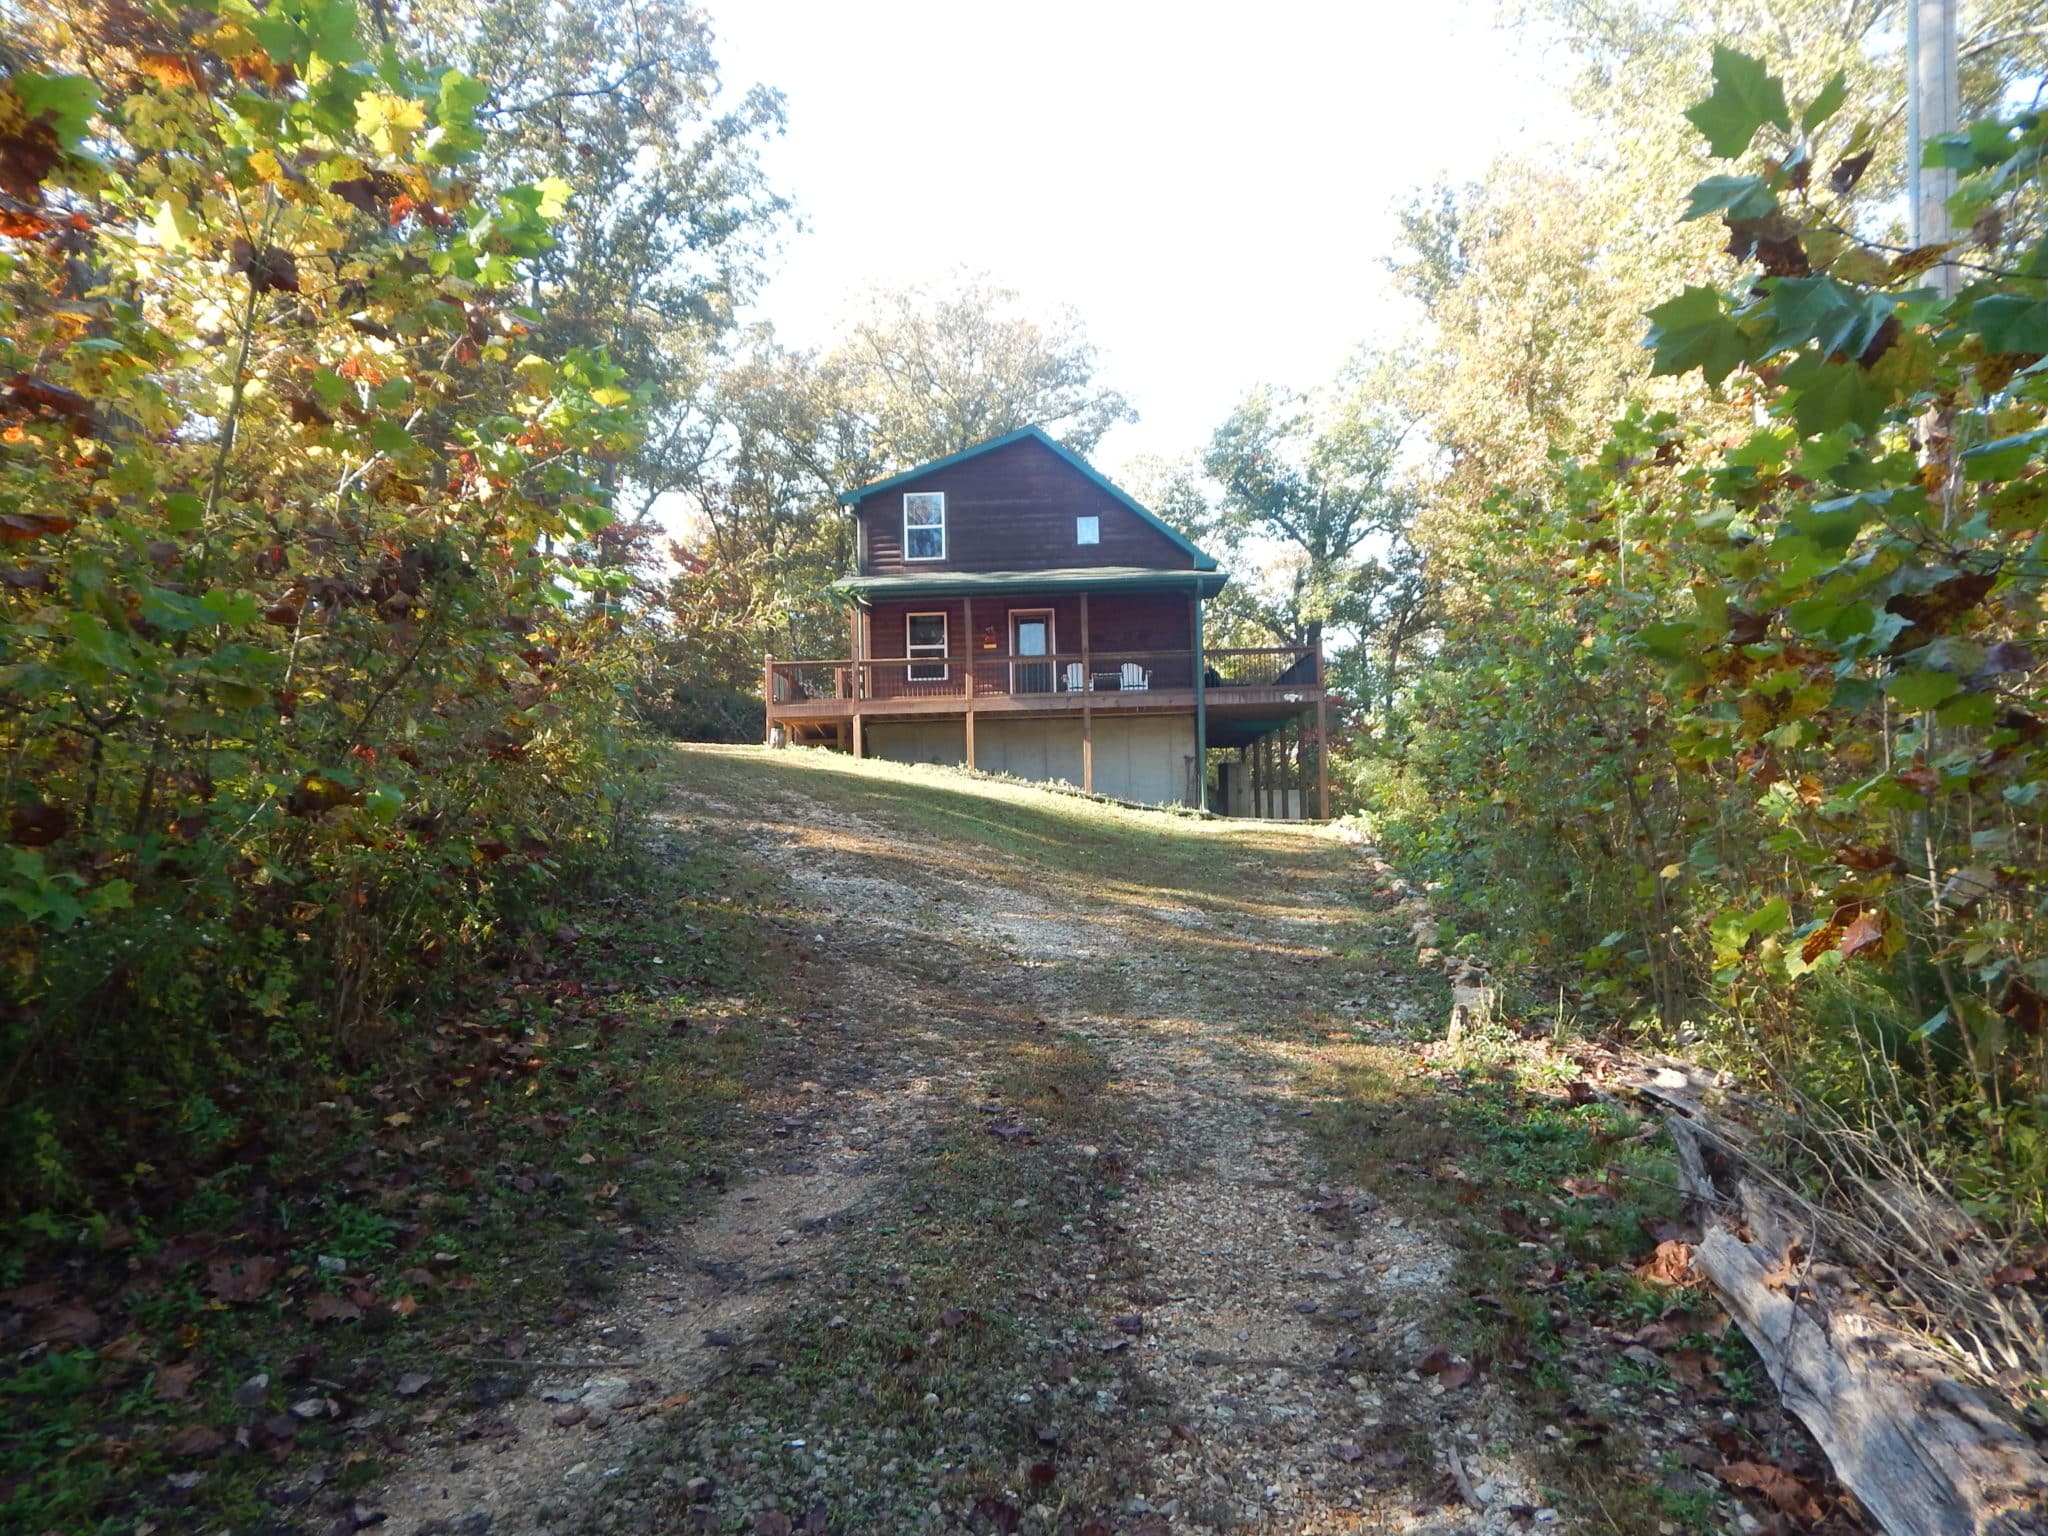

left=866, top=715, right=1194, bottom=805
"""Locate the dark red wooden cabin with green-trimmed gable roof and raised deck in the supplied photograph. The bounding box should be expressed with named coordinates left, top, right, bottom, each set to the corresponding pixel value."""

left=762, top=426, right=1329, bottom=817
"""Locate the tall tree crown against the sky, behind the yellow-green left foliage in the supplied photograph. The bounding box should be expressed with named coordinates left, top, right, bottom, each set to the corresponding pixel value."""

left=408, top=0, right=788, bottom=510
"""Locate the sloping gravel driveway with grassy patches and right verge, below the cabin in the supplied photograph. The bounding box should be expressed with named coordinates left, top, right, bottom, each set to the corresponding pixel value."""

left=362, top=750, right=1875, bottom=1536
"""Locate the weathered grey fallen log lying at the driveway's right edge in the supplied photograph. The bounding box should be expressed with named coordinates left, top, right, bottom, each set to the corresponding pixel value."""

left=1630, top=1067, right=2048, bottom=1536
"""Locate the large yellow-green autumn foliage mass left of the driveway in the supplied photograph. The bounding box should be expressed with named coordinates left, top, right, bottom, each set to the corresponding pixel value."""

left=0, top=0, right=637, bottom=1204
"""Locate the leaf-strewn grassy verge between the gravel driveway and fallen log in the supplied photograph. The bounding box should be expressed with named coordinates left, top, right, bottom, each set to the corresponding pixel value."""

left=1303, top=1028, right=1862, bottom=1536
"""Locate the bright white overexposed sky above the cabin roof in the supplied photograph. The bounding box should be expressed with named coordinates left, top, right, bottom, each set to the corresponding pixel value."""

left=696, top=0, right=1569, bottom=475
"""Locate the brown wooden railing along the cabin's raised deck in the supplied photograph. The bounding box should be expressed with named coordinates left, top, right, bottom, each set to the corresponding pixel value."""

left=762, top=645, right=1317, bottom=707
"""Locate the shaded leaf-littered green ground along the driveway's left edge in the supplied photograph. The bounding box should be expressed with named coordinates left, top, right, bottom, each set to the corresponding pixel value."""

left=0, top=834, right=799, bottom=1532
